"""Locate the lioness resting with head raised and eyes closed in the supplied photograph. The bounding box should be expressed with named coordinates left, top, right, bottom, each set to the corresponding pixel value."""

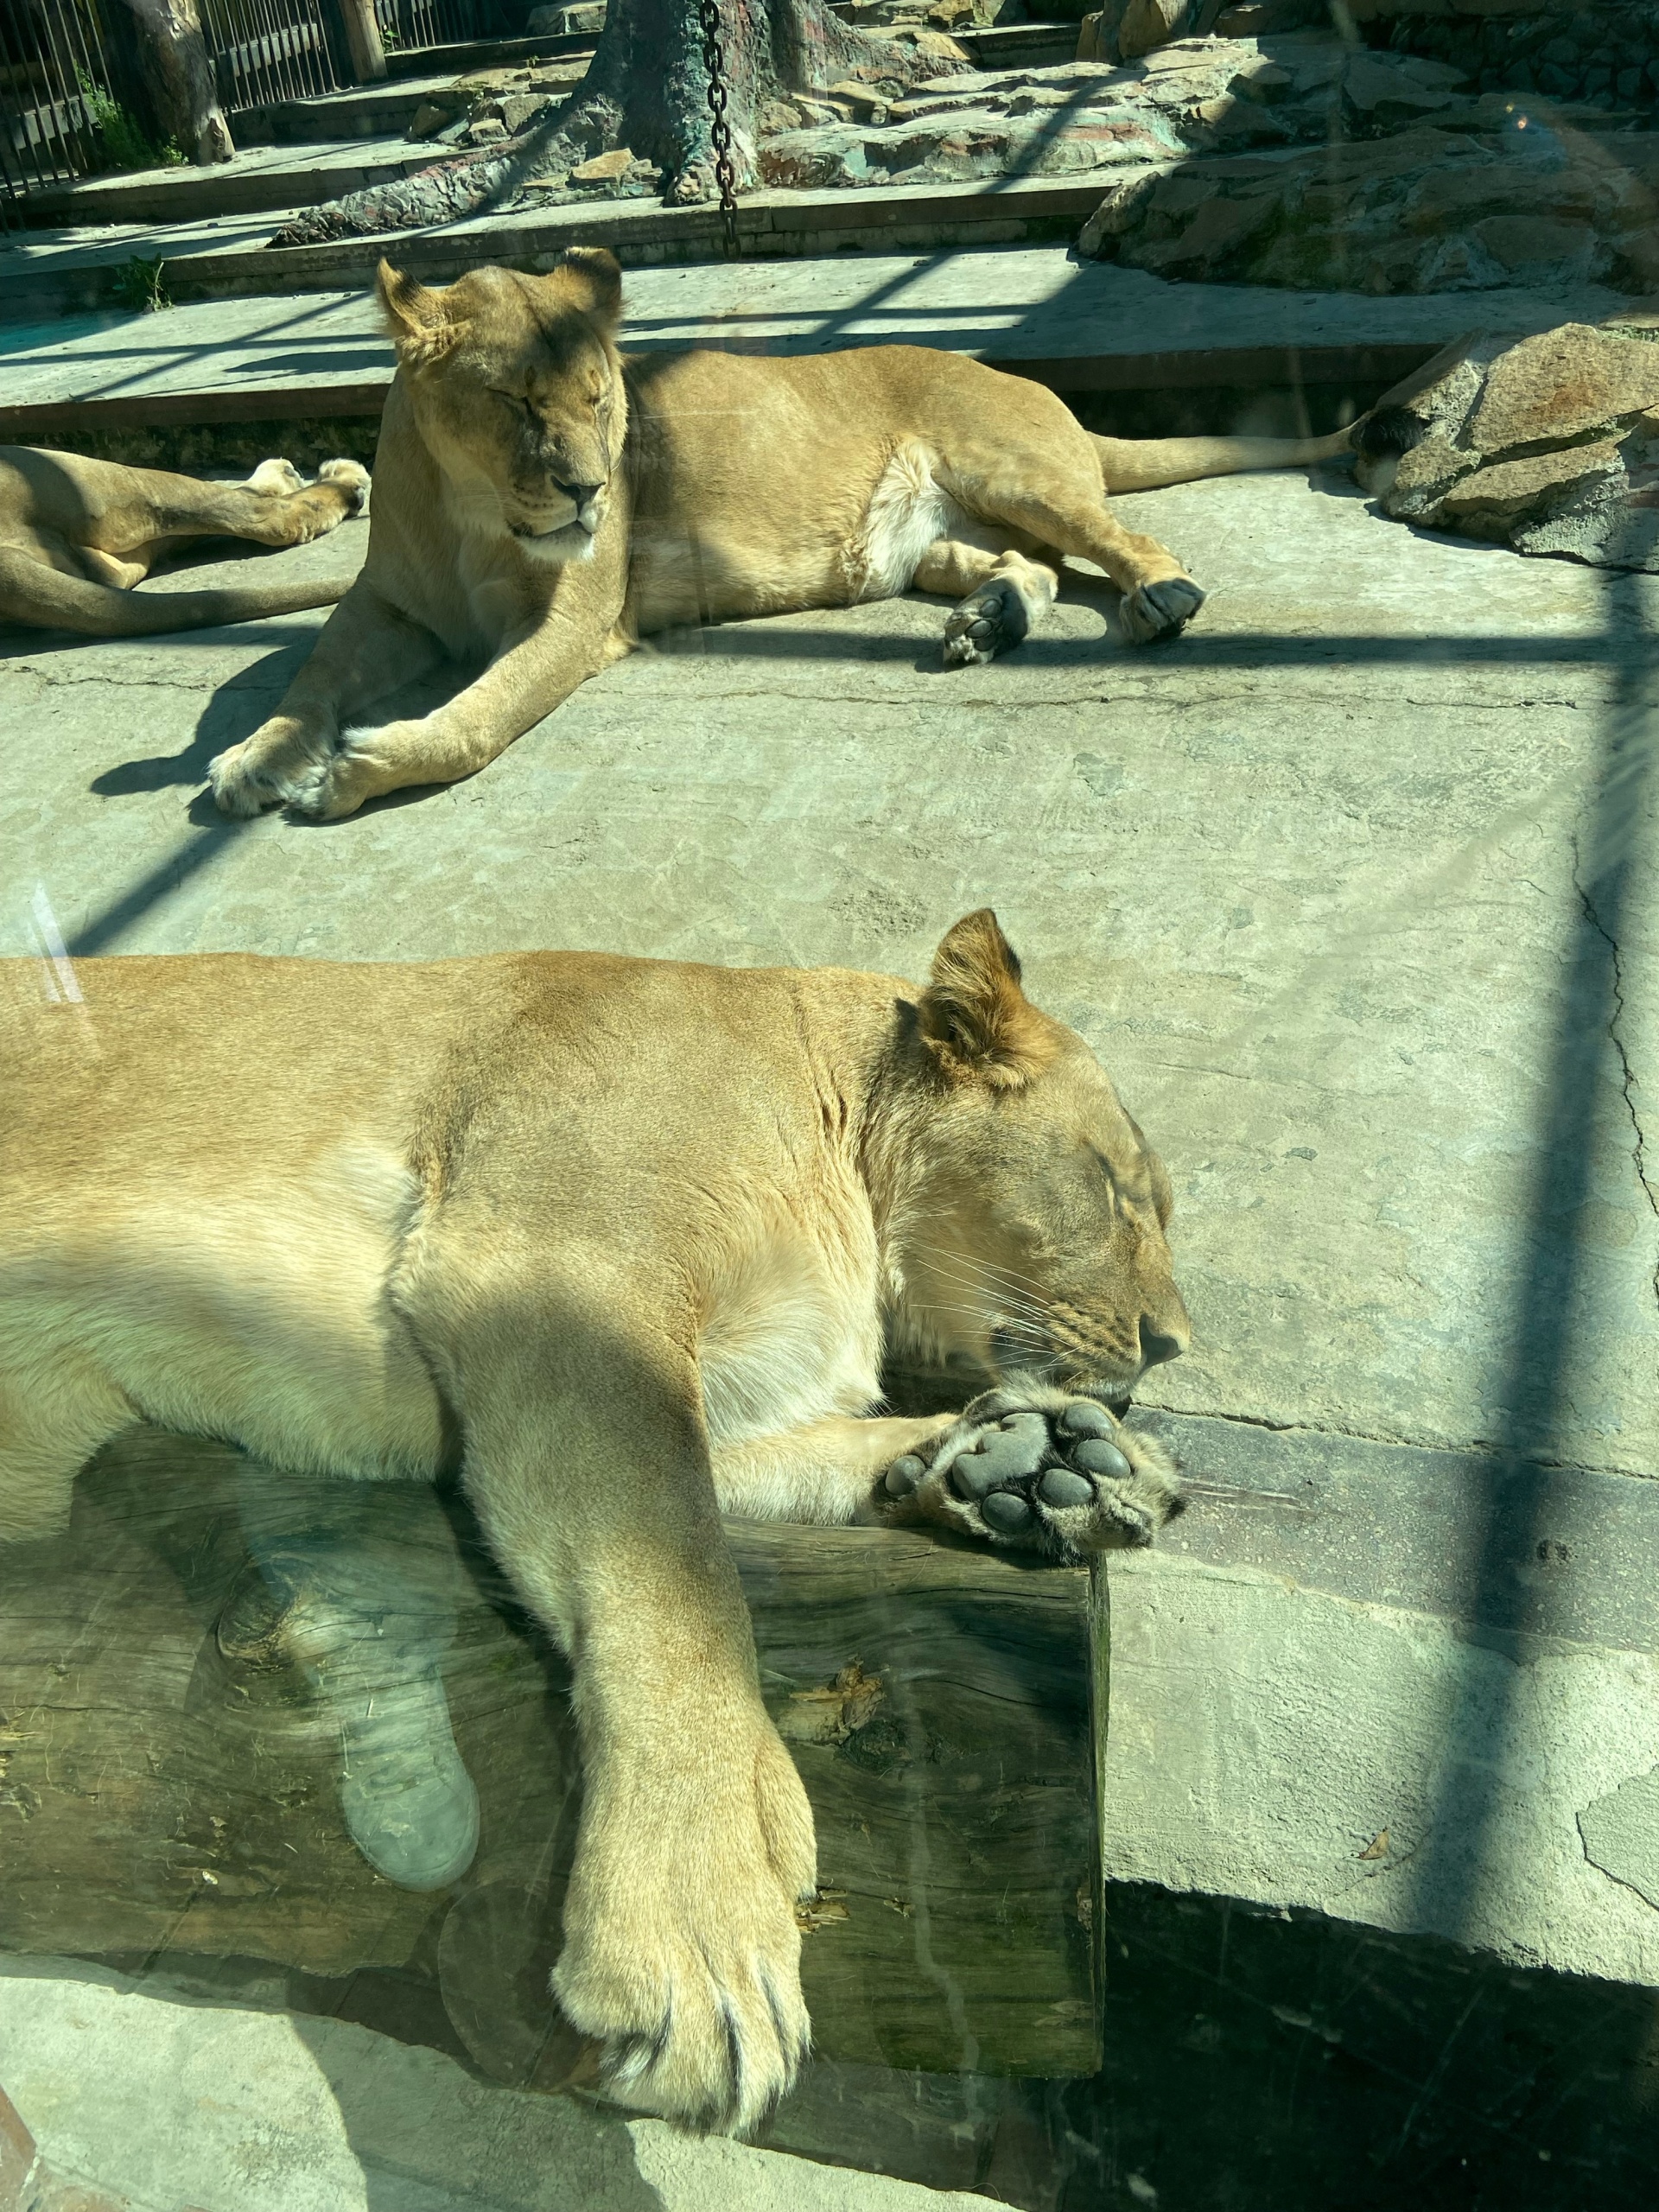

left=208, top=250, right=1347, bottom=818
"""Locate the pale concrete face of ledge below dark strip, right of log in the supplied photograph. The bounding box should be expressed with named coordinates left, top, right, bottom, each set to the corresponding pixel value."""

left=1102, top=1544, right=1659, bottom=1988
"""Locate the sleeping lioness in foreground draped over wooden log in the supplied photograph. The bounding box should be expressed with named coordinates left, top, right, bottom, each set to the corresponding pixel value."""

left=0, top=912, right=1188, bottom=2128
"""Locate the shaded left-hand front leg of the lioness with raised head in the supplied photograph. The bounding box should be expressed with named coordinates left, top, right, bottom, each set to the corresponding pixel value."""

left=208, top=577, right=442, bottom=817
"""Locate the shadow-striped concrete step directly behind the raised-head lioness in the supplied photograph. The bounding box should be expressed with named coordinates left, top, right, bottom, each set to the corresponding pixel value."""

left=0, top=245, right=1617, bottom=467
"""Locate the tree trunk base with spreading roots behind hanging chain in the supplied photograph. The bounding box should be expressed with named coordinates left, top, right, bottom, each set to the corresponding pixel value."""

left=270, top=0, right=964, bottom=245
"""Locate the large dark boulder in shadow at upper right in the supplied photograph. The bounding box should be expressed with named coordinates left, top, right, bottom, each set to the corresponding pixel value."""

left=1079, top=111, right=1659, bottom=292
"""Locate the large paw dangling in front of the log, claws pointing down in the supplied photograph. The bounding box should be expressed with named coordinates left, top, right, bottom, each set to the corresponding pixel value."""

left=553, top=1721, right=817, bottom=2134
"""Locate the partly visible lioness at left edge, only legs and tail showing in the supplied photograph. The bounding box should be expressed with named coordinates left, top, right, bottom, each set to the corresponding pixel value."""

left=0, top=445, right=370, bottom=637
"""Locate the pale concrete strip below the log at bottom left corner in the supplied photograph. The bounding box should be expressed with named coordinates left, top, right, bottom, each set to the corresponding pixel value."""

left=0, top=1960, right=1013, bottom=2212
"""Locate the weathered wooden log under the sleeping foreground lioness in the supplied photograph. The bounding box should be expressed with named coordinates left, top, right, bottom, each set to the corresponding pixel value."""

left=0, top=1431, right=1099, bottom=2088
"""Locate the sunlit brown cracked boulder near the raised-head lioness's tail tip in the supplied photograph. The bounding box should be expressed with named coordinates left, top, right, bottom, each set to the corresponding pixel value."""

left=1356, top=323, right=1659, bottom=570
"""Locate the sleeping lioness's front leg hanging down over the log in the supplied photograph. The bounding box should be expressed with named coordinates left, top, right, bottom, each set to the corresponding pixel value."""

left=454, top=1314, right=817, bottom=2130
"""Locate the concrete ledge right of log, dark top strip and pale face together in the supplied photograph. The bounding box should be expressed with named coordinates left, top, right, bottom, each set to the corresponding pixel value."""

left=1102, top=1415, right=1659, bottom=1988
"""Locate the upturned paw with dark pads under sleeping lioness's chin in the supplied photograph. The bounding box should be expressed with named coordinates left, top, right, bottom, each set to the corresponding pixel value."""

left=876, top=1385, right=1181, bottom=1564
